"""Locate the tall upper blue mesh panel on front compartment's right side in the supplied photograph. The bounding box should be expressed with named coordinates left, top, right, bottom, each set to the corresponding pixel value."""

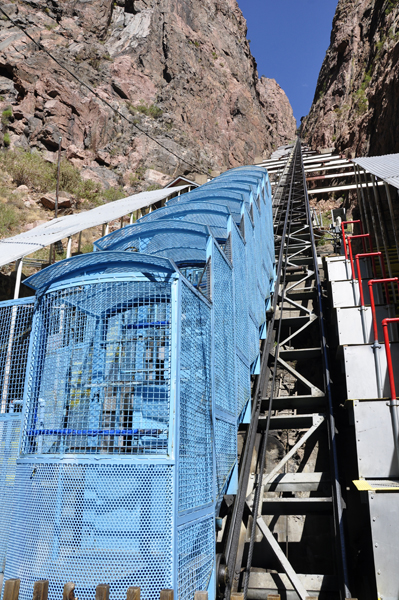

left=179, top=283, right=213, bottom=512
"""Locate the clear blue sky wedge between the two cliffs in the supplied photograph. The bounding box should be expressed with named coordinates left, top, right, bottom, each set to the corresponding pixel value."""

left=238, top=0, right=338, bottom=122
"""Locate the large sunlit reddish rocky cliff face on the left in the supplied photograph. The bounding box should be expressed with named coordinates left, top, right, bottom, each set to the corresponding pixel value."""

left=0, top=0, right=296, bottom=188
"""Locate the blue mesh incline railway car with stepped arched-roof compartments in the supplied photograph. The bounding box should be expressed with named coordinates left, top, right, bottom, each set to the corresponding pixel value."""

left=0, top=167, right=275, bottom=600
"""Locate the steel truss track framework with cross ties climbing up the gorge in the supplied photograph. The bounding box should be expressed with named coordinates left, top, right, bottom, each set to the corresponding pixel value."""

left=223, top=139, right=350, bottom=600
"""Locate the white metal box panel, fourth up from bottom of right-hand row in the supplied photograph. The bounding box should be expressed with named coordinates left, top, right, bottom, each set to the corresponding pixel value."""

left=336, top=306, right=397, bottom=346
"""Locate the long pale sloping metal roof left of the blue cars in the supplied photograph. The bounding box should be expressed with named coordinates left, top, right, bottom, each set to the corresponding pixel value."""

left=0, top=186, right=187, bottom=266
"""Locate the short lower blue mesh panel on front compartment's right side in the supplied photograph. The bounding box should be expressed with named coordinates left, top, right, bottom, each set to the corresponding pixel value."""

left=178, top=517, right=215, bottom=600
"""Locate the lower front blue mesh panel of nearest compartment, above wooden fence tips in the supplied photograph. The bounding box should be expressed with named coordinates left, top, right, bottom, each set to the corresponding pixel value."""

left=4, top=463, right=173, bottom=600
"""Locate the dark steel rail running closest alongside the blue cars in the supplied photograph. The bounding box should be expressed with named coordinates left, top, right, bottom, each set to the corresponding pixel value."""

left=224, top=144, right=298, bottom=600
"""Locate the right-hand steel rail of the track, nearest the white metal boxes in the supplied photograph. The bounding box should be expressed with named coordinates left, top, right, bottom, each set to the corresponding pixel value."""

left=299, top=142, right=351, bottom=599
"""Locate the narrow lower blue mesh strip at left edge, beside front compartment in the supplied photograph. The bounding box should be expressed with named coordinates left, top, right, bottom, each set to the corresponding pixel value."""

left=0, top=415, right=21, bottom=570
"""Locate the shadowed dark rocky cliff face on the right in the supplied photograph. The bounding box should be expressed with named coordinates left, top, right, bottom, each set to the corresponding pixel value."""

left=304, top=0, right=399, bottom=157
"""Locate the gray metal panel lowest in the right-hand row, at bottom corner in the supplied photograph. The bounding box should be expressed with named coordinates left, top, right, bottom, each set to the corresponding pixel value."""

left=367, top=492, right=399, bottom=600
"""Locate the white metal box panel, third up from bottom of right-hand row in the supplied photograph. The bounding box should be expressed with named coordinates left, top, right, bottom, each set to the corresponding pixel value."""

left=344, top=342, right=399, bottom=400
